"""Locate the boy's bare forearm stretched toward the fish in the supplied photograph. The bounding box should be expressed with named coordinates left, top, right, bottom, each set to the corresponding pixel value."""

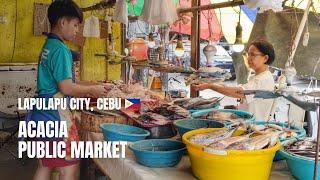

left=58, top=79, right=108, bottom=98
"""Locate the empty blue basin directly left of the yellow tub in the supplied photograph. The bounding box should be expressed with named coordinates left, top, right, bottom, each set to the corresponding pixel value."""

left=129, top=139, right=186, bottom=168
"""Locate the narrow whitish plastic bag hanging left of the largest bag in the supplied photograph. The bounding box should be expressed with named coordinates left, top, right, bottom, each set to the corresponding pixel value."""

left=113, top=0, right=128, bottom=25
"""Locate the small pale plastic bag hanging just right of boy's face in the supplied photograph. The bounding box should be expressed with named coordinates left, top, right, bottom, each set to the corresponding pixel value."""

left=83, top=16, right=100, bottom=38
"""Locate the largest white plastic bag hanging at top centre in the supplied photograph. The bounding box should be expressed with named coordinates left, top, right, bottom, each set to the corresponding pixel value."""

left=139, top=0, right=179, bottom=25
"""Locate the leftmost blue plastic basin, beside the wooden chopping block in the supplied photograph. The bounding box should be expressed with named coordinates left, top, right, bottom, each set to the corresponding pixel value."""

left=100, top=123, right=150, bottom=142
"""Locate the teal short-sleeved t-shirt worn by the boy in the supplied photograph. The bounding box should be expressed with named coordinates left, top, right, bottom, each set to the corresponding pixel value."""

left=37, top=38, right=73, bottom=95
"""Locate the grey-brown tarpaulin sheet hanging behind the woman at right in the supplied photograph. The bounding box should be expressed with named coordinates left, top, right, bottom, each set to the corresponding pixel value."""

left=249, top=8, right=320, bottom=79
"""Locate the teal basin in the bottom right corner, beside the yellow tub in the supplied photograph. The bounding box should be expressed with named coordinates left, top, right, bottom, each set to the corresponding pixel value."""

left=279, top=149, right=320, bottom=180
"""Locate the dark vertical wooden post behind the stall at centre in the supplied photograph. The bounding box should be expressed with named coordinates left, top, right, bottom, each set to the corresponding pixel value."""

left=190, top=0, right=200, bottom=97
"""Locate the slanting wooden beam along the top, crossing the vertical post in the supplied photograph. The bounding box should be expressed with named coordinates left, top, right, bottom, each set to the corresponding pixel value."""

left=177, top=0, right=244, bottom=13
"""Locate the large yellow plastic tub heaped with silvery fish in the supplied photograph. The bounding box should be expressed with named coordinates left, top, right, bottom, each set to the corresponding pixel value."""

left=182, top=128, right=280, bottom=180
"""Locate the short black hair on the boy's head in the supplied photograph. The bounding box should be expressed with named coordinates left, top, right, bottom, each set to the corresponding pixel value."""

left=48, top=0, right=83, bottom=27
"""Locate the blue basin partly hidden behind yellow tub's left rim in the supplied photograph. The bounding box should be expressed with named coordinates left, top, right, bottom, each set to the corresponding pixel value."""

left=173, top=119, right=226, bottom=137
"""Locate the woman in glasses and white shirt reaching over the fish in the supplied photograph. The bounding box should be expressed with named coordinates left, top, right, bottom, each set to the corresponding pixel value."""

left=191, top=40, right=275, bottom=120
